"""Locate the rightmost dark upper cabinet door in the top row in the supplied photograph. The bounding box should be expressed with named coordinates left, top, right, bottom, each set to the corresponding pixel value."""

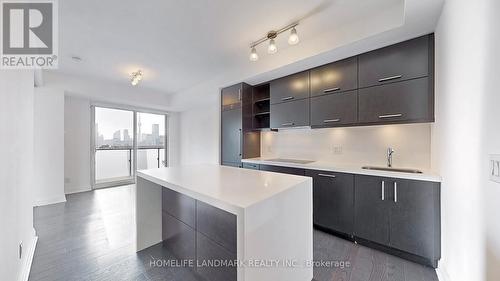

left=359, top=35, right=430, bottom=88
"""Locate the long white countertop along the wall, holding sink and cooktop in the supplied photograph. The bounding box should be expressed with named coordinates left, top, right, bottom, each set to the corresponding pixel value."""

left=242, top=158, right=441, bottom=182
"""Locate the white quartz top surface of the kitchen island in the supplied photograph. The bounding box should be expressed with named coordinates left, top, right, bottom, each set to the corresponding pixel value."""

left=137, top=164, right=312, bottom=213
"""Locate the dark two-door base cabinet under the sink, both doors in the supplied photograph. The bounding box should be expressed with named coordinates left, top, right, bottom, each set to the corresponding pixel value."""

left=354, top=175, right=441, bottom=267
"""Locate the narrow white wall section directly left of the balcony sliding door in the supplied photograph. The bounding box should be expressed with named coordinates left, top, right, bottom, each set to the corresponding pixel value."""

left=64, top=96, right=91, bottom=194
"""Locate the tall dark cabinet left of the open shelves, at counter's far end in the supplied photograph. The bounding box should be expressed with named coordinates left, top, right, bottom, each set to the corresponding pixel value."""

left=221, top=83, right=260, bottom=167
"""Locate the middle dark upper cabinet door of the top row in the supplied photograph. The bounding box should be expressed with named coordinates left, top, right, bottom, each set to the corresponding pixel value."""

left=311, top=57, right=358, bottom=97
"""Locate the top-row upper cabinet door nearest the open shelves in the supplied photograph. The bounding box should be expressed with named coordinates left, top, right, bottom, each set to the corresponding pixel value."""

left=270, top=71, right=309, bottom=104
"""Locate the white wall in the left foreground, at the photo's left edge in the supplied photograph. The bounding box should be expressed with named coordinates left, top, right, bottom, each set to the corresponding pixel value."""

left=0, top=70, right=35, bottom=281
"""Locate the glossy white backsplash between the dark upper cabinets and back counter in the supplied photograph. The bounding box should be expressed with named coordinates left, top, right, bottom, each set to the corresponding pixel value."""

left=261, top=124, right=431, bottom=170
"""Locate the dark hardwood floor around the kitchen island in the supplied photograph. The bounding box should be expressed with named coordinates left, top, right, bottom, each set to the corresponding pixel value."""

left=29, top=186, right=438, bottom=281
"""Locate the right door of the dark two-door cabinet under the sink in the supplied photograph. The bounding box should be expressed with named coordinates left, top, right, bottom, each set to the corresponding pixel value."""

left=389, top=180, right=440, bottom=259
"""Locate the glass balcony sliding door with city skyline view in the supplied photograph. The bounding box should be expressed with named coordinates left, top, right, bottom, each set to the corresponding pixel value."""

left=91, top=106, right=167, bottom=188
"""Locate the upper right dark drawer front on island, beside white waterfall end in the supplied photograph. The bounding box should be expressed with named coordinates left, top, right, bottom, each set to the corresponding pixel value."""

left=196, top=201, right=237, bottom=253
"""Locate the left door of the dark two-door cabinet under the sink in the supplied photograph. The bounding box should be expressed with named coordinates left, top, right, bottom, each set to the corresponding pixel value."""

left=354, top=175, right=391, bottom=246
